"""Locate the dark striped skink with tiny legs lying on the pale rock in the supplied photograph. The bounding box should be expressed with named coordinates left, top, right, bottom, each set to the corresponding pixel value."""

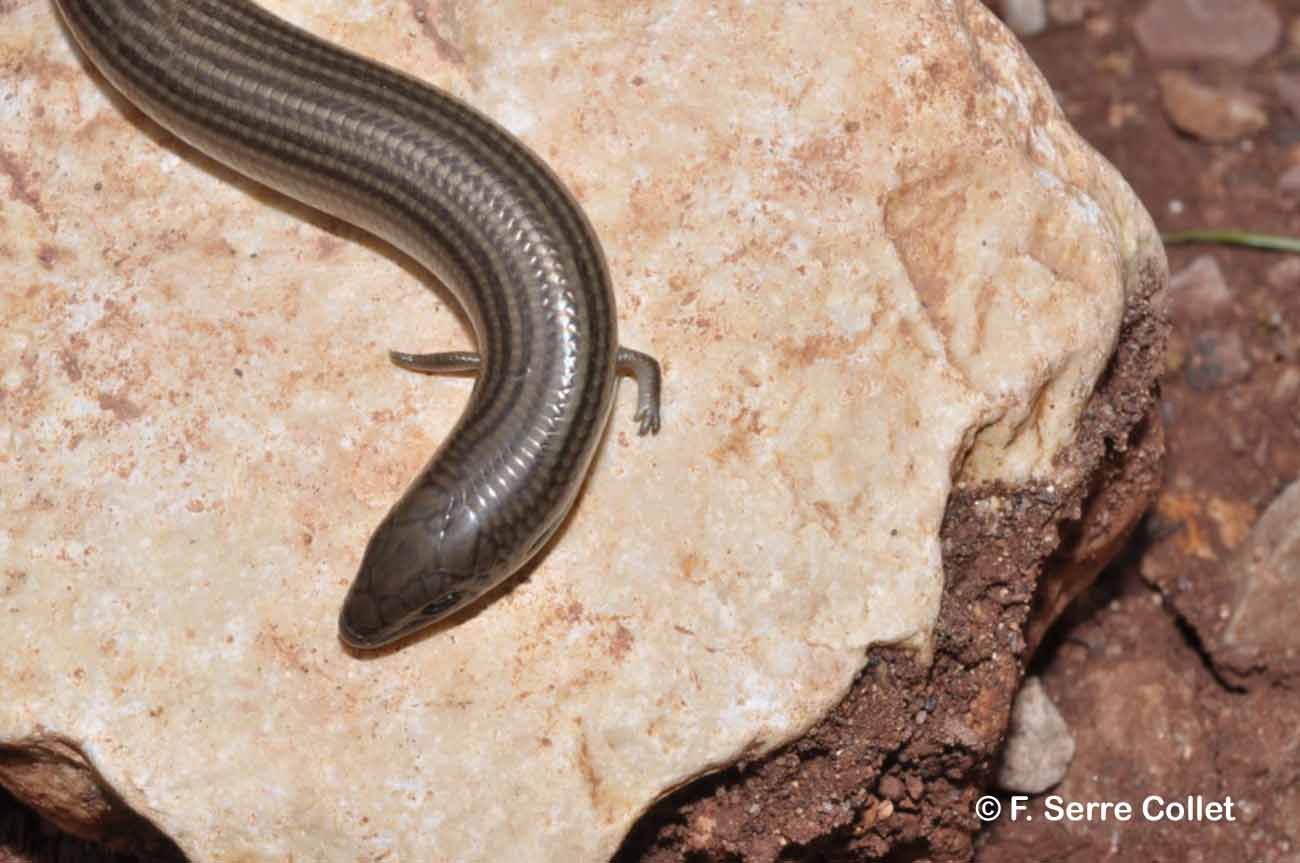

left=56, top=0, right=659, bottom=647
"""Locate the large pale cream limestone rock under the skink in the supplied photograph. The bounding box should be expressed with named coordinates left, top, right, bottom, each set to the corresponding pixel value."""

left=0, top=0, right=1164, bottom=862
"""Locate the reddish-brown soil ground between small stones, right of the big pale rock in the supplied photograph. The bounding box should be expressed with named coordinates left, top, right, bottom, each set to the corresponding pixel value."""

left=975, top=0, right=1300, bottom=863
